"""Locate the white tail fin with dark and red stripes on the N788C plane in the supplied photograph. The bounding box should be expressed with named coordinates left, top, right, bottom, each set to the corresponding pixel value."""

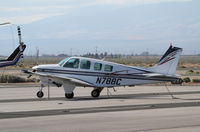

left=150, top=45, right=182, bottom=75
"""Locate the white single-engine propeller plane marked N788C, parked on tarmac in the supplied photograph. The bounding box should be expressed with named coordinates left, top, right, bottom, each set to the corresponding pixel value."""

left=23, top=45, right=182, bottom=99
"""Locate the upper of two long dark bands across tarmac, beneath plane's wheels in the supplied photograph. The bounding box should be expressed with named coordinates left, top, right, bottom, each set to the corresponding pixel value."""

left=0, top=91, right=200, bottom=103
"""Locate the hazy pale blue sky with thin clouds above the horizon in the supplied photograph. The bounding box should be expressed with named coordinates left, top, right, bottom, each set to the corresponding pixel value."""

left=0, top=0, right=200, bottom=55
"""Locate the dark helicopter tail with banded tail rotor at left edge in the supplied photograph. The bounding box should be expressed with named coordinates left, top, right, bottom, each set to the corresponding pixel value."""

left=0, top=23, right=26, bottom=67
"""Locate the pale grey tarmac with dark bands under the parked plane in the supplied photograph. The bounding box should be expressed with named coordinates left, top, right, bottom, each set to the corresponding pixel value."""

left=0, top=84, right=200, bottom=132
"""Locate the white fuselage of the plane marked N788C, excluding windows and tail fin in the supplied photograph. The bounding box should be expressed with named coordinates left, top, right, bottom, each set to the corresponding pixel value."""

left=33, top=58, right=167, bottom=87
